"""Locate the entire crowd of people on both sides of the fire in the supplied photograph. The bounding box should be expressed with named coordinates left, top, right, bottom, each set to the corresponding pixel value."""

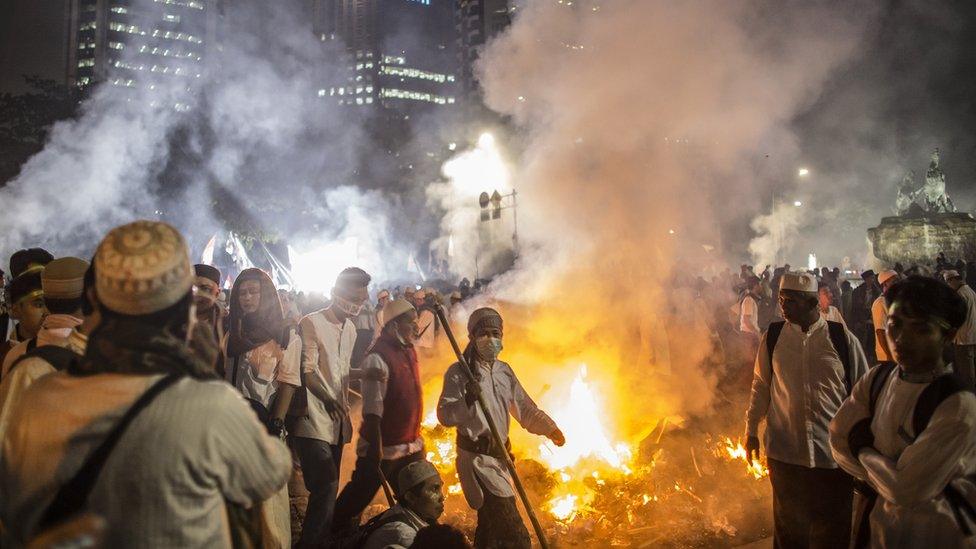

left=0, top=221, right=976, bottom=549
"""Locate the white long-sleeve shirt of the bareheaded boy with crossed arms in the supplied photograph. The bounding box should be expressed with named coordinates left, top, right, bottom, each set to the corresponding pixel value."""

left=830, top=368, right=976, bottom=549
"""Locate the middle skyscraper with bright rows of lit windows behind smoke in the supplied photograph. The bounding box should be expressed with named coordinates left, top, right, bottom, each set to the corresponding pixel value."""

left=315, top=0, right=457, bottom=112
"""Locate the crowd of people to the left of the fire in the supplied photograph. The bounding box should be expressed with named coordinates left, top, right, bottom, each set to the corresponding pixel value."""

left=0, top=221, right=565, bottom=549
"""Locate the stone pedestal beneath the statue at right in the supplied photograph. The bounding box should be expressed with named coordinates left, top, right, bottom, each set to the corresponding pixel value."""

left=868, top=207, right=976, bottom=267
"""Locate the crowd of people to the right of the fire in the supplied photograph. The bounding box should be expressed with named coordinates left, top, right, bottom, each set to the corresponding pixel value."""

left=733, top=256, right=976, bottom=548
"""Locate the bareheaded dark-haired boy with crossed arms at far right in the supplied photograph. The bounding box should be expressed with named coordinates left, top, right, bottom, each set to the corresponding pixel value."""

left=830, top=276, right=976, bottom=548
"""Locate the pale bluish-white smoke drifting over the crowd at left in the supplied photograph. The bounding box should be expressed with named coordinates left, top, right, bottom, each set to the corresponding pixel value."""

left=0, top=0, right=404, bottom=276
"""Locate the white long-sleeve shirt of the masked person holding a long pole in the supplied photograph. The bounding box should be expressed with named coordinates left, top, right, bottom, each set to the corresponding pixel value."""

left=437, top=360, right=556, bottom=509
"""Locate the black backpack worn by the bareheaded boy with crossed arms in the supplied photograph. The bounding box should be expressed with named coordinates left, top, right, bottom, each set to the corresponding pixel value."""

left=868, top=362, right=976, bottom=537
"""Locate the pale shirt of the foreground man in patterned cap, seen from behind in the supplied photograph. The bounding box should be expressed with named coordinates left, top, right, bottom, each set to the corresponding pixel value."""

left=0, top=366, right=291, bottom=548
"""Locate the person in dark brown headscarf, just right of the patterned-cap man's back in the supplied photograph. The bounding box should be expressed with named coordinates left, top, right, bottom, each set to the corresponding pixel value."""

left=221, top=269, right=302, bottom=547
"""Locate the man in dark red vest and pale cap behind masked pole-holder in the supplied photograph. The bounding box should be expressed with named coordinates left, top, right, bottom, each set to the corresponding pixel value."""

left=333, top=299, right=424, bottom=533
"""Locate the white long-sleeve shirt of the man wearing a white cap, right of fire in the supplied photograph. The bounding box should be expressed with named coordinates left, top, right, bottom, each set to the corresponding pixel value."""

left=746, top=318, right=867, bottom=469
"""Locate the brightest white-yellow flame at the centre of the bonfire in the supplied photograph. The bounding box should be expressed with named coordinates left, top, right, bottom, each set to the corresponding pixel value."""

left=539, top=364, right=632, bottom=474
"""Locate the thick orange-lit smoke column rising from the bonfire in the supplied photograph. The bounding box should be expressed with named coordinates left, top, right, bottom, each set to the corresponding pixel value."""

left=466, top=0, right=873, bottom=430
